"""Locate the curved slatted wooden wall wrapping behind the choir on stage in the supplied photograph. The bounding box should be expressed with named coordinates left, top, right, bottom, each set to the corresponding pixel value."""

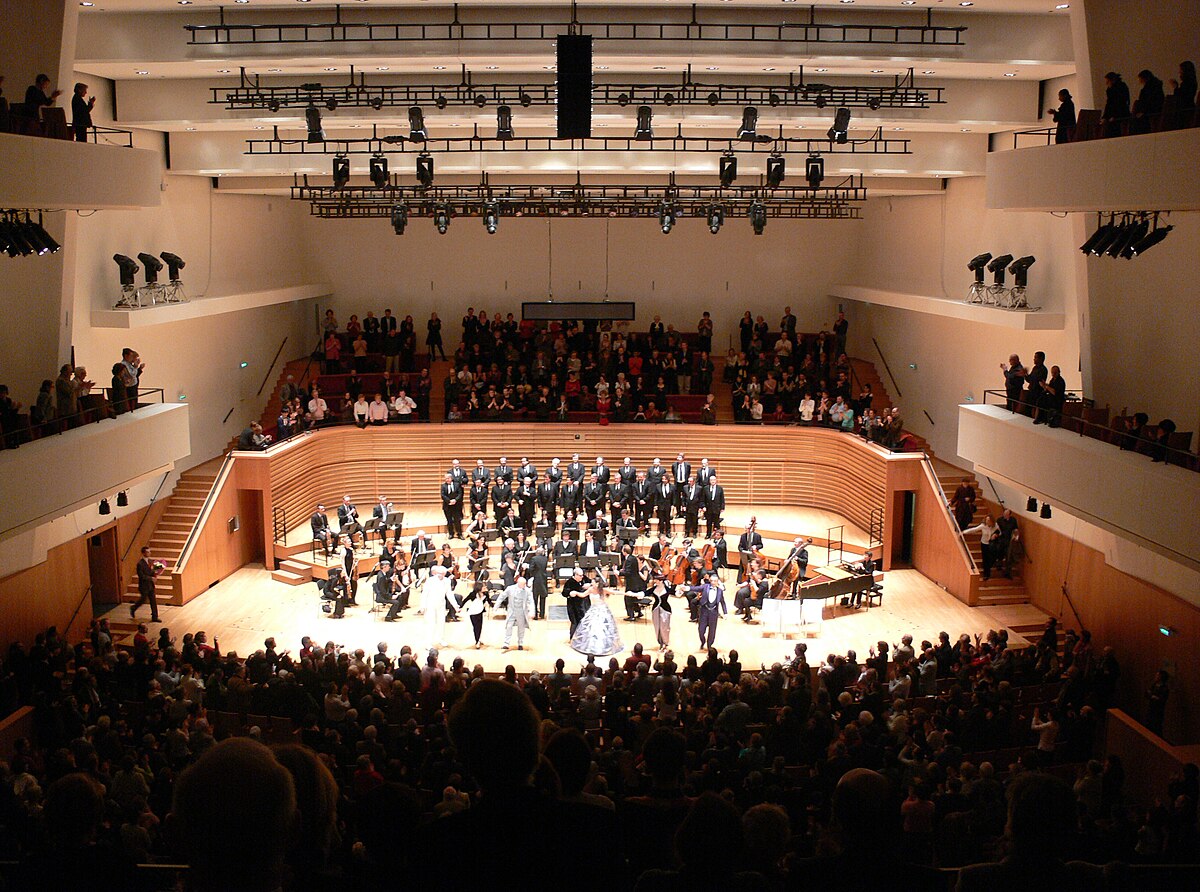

left=229, top=423, right=920, bottom=565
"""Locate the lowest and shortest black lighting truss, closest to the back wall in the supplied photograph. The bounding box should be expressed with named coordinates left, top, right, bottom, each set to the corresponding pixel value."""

left=292, top=175, right=866, bottom=220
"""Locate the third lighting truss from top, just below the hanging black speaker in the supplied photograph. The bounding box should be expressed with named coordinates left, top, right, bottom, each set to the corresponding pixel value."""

left=245, top=125, right=912, bottom=155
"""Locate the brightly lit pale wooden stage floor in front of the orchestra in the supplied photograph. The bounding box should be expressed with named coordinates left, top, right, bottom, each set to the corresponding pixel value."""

left=108, top=564, right=1046, bottom=672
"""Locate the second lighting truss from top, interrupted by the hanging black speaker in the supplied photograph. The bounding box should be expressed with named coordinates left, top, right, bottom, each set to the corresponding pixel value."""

left=209, top=66, right=946, bottom=113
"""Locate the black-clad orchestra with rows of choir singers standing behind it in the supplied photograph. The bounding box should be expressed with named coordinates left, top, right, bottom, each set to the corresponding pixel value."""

left=300, top=453, right=880, bottom=648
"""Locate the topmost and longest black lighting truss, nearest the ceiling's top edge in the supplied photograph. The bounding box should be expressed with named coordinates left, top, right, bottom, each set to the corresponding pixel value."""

left=184, top=4, right=967, bottom=47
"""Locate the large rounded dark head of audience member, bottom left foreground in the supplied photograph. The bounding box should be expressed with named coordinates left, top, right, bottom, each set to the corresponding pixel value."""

left=172, top=737, right=298, bottom=892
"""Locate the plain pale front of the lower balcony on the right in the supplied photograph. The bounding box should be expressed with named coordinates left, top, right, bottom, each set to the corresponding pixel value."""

left=958, top=406, right=1200, bottom=570
